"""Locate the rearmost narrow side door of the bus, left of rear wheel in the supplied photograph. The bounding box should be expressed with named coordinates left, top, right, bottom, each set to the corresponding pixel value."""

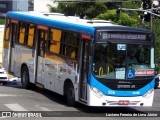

left=9, top=23, right=18, bottom=73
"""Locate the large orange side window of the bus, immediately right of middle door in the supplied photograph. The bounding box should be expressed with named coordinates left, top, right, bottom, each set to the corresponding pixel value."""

left=49, top=29, right=62, bottom=54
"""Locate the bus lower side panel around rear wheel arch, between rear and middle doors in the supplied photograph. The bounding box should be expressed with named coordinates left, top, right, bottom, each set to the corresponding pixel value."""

left=14, top=44, right=35, bottom=83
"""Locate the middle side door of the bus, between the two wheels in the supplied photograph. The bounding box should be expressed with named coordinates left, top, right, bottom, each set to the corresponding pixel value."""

left=36, top=29, right=48, bottom=86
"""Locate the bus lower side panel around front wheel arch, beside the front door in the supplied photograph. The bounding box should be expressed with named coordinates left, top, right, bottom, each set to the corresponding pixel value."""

left=55, top=58, right=78, bottom=97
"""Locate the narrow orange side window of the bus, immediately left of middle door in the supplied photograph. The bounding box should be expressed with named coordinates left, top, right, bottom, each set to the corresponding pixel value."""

left=27, top=24, right=35, bottom=47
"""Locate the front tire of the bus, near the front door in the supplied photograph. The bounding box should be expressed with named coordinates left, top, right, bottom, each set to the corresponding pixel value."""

left=66, top=82, right=76, bottom=106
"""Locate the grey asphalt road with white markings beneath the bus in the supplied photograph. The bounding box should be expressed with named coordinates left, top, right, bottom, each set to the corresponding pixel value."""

left=0, top=82, right=160, bottom=120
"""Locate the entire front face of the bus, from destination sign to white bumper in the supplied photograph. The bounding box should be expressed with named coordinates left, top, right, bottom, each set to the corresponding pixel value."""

left=88, top=30, right=155, bottom=106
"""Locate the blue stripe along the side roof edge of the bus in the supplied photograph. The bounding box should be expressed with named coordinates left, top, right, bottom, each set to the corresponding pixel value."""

left=7, top=12, right=95, bottom=37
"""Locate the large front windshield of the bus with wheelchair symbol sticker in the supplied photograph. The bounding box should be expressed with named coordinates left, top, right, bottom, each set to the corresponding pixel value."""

left=93, top=42, right=155, bottom=79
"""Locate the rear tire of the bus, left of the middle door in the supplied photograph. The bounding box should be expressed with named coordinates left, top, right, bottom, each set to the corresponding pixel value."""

left=21, top=66, right=30, bottom=89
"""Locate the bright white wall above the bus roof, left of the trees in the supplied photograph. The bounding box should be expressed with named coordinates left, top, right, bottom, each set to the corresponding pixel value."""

left=34, top=0, right=54, bottom=12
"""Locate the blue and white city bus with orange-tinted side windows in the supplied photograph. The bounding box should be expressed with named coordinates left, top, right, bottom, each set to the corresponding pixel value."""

left=3, top=12, right=156, bottom=106
